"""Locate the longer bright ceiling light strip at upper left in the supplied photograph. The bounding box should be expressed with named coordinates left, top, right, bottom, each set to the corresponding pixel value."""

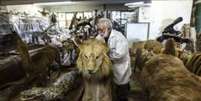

left=34, top=1, right=78, bottom=6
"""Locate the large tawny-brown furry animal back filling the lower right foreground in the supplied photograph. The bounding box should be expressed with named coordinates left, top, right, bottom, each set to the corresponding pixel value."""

left=140, top=38, right=201, bottom=101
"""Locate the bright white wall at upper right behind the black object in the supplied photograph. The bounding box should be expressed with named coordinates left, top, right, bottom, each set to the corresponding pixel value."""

left=139, top=0, right=193, bottom=39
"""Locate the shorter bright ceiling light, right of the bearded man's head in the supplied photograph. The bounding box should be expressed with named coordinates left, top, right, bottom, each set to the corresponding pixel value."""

left=125, top=2, right=150, bottom=8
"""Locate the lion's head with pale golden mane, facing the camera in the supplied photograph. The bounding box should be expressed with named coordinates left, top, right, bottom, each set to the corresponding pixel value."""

left=77, top=39, right=111, bottom=78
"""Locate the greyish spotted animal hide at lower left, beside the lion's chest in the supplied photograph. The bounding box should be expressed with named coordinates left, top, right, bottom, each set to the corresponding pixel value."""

left=18, top=71, right=78, bottom=101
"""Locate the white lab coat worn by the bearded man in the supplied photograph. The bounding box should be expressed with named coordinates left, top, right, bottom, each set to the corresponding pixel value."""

left=98, top=30, right=132, bottom=85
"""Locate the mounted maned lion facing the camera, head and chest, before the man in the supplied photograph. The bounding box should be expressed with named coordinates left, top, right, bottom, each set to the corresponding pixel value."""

left=77, top=39, right=112, bottom=101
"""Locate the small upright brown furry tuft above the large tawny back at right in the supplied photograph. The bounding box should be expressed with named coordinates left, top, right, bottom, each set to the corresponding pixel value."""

left=163, top=38, right=178, bottom=56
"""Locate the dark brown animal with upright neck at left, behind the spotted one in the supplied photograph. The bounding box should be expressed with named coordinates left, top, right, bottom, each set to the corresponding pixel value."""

left=16, top=33, right=60, bottom=83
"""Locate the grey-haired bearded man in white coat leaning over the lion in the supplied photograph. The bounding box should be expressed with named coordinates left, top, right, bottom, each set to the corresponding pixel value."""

left=97, top=18, right=131, bottom=101
